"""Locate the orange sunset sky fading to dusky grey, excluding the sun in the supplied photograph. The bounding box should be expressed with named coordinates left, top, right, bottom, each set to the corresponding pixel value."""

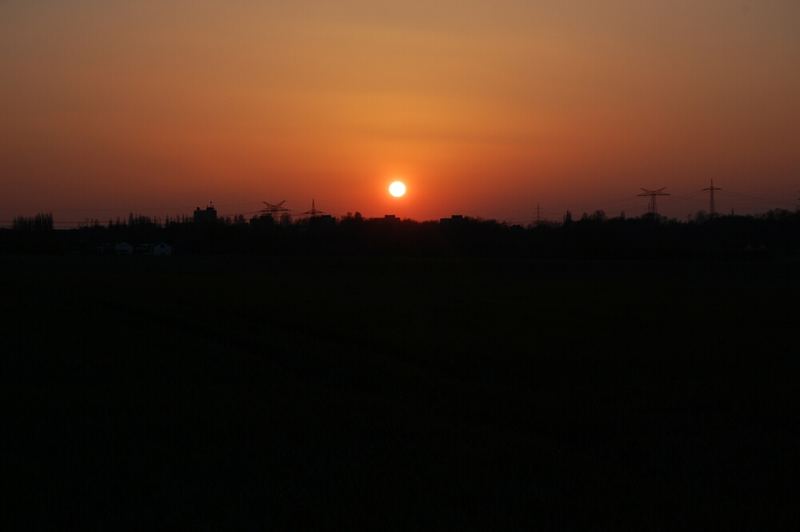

left=0, top=0, right=800, bottom=221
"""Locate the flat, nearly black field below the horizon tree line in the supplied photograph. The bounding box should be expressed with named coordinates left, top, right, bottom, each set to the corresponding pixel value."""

left=0, top=257, right=800, bottom=530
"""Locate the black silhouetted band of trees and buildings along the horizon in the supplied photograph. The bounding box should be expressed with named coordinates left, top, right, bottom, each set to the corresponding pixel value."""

left=0, top=210, right=800, bottom=259
